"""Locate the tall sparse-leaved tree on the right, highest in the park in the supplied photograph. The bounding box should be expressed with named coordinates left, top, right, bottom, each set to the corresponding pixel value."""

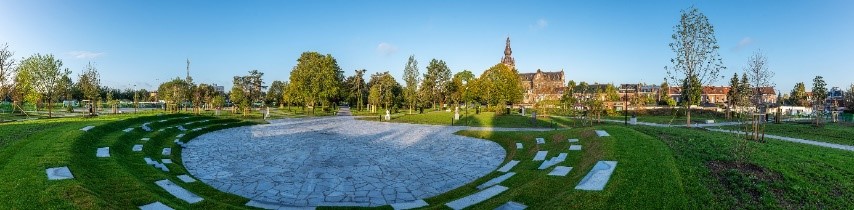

left=665, top=7, right=726, bottom=127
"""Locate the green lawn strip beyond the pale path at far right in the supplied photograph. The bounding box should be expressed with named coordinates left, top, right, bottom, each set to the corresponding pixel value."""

left=720, top=122, right=854, bottom=145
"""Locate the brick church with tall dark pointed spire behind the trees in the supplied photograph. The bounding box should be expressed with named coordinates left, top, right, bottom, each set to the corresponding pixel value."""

left=501, top=37, right=566, bottom=107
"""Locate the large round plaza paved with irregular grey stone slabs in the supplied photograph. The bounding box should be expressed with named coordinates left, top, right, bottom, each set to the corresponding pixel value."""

left=182, top=111, right=506, bottom=207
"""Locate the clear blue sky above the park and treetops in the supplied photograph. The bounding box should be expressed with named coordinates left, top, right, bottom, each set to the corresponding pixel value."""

left=0, top=0, right=854, bottom=93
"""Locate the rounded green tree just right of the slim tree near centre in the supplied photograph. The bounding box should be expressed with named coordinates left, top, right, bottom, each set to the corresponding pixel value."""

left=421, top=58, right=451, bottom=109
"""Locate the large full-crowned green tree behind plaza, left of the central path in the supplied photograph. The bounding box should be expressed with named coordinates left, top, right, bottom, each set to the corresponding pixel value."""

left=290, top=52, right=344, bottom=112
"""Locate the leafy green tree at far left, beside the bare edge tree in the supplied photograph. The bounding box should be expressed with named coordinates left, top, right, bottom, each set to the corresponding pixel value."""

left=19, top=54, right=71, bottom=117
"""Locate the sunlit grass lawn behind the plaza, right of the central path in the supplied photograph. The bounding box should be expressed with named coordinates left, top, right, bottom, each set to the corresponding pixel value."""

left=360, top=110, right=575, bottom=128
